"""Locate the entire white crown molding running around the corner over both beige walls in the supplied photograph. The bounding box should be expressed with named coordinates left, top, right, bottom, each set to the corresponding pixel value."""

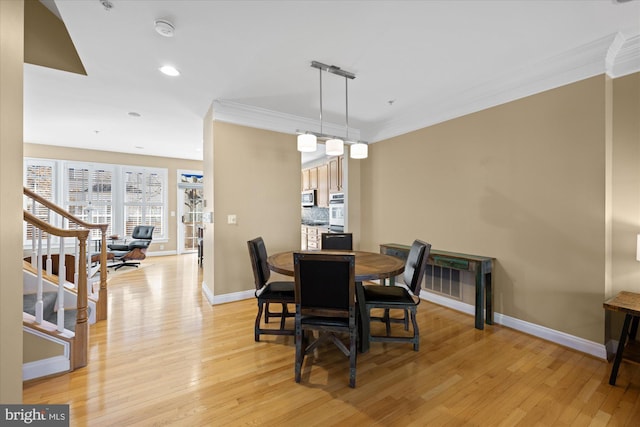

left=213, top=28, right=640, bottom=143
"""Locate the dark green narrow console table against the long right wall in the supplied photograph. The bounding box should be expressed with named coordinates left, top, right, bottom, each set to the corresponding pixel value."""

left=380, top=243, right=494, bottom=329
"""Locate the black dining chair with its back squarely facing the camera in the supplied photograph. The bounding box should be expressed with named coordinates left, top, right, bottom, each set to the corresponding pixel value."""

left=293, top=252, right=358, bottom=387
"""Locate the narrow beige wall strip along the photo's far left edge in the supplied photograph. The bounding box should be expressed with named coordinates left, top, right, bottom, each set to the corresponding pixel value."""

left=0, top=0, right=24, bottom=404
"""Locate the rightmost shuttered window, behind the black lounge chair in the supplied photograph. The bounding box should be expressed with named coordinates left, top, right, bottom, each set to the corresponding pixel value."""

left=122, top=167, right=167, bottom=239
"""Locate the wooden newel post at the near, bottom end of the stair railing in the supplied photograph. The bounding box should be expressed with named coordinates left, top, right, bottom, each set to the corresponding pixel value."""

left=73, top=230, right=89, bottom=369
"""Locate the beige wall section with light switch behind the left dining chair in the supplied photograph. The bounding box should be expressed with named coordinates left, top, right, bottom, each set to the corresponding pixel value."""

left=210, top=121, right=301, bottom=295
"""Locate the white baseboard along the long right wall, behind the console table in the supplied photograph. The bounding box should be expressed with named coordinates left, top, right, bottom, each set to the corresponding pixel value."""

left=420, top=292, right=607, bottom=360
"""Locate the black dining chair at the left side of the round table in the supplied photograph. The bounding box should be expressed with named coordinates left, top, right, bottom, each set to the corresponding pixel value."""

left=247, top=237, right=295, bottom=341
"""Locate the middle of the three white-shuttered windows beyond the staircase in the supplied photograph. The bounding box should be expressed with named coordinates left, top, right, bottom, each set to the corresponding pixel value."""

left=64, top=163, right=114, bottom=239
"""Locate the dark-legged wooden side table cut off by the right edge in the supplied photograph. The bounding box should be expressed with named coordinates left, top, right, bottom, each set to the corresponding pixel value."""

left=602, top=291, right=640, bottom=385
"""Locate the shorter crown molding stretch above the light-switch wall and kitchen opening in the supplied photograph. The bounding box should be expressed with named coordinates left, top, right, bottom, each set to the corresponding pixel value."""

left=213, top=99, right=360, bottom=140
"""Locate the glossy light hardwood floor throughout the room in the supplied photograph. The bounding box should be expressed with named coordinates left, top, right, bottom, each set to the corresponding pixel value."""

left=24, top=255, right=640, bottom=426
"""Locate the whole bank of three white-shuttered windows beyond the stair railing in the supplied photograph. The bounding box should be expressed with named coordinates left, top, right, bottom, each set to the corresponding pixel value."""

left=23, top=158, right=168, bottom=244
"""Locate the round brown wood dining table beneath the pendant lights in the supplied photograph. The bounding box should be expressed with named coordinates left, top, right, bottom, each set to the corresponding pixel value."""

left=267, top=250, right=405, bottom=353
